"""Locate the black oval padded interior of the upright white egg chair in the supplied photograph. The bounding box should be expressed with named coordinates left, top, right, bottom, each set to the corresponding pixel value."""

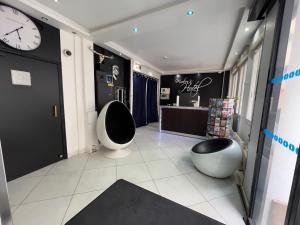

left=105, top=101, right=135, bottom=144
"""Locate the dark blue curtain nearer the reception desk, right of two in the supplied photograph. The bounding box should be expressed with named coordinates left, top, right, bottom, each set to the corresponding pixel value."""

left=147, top=78, right=158, bottom=123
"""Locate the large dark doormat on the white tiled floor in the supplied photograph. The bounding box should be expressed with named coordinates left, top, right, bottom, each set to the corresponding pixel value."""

left=66, top=180, right=222, bottom=225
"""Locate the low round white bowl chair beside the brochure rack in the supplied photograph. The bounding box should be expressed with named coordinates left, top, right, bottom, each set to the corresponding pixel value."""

left=191, top=138, right=242, bottom=178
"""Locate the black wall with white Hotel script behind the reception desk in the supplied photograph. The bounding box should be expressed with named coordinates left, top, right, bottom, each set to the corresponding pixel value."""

left=160, top=71, right=230, bottom=106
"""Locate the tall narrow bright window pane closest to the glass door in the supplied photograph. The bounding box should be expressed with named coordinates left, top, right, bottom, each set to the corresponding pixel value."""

left=246, top=46, right=262, bottom=121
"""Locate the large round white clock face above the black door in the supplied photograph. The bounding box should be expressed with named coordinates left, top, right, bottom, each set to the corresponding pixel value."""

left=0, top=4, right=41, bottom=51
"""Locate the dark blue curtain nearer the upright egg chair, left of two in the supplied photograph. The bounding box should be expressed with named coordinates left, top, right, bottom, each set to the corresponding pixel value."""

left=132, top=73, right=147, bottom=127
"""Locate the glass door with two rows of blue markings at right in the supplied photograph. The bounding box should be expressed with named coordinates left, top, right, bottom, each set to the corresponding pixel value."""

left=249, top=0, right=300, bottom=225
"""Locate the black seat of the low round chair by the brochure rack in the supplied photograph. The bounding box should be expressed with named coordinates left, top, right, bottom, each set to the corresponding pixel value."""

left=192, top=138, right=233, bottom=154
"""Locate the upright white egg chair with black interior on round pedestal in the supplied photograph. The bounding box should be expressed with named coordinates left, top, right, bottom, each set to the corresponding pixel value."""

left=97, top=101, right=135, bottom=159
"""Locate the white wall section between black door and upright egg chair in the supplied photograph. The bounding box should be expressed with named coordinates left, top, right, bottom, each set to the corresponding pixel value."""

left=60, top=30, right=97, bottom=157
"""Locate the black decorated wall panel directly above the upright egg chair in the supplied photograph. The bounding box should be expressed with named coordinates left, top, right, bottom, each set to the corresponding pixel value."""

left=94, top=45, right=130, bottom=113
